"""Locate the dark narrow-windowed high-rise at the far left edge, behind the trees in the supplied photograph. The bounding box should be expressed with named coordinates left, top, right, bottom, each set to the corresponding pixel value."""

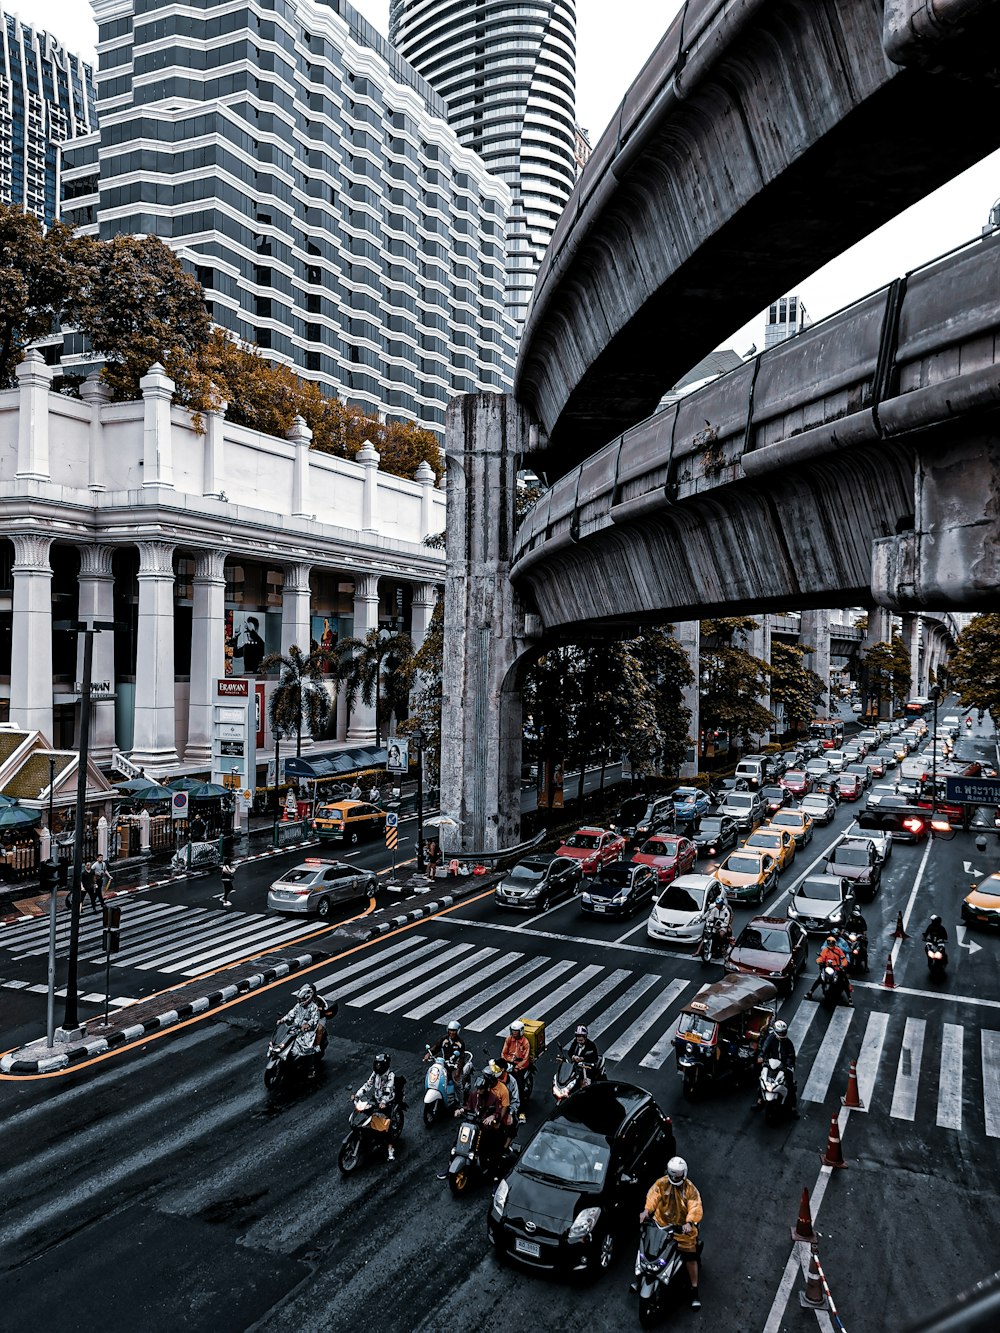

left=0, top=0, right=97, bottom=225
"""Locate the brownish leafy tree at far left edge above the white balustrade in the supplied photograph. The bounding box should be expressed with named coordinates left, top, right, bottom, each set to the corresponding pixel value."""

left=0, top=207, right=92, bottom=389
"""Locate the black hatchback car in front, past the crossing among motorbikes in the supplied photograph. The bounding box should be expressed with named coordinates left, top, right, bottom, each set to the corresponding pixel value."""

left=487, top=1082, right=675, bottom=1276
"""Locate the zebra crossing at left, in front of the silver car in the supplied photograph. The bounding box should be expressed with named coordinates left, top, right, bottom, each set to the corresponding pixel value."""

left=0, top=898, right=321, bottom=977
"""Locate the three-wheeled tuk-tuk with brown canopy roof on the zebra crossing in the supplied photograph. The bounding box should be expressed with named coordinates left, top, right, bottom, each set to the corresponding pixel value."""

left=673, top=972, right=777, bottom=1098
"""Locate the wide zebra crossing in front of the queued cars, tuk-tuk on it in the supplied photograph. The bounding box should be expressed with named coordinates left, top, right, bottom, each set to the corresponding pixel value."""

left=316, top=934, right=1000, bottom=1138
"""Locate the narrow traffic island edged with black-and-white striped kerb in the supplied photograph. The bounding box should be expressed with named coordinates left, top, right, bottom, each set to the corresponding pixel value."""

left=0, top=853, right=500, bottom=1077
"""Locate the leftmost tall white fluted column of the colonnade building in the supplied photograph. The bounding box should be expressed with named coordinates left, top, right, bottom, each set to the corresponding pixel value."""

left=11, top=532, right=52, bottom=742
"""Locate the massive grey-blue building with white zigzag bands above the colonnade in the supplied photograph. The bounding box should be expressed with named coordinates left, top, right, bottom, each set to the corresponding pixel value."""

left=64, top=0, right=515, bottom=431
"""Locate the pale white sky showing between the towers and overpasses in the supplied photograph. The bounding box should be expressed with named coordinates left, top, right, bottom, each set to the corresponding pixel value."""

left=7, top=0, right=1000, bottom=355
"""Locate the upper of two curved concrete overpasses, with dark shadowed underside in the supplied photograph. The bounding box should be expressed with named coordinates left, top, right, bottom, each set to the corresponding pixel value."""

left=515, top=0, right=1000, bottom=477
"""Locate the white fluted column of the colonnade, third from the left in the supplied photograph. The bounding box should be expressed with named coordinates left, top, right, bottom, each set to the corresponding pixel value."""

left=131, top=541, right=177, bottom=768
